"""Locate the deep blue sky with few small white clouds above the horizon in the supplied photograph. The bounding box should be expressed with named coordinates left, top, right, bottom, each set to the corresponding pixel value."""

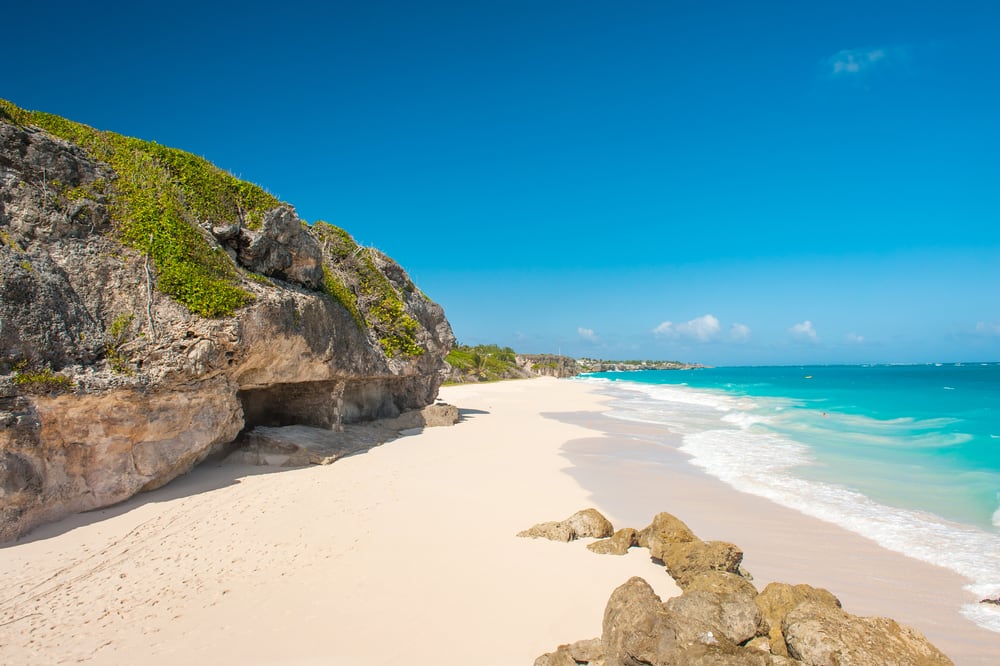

left=7, top=0, right=1000, bottom=364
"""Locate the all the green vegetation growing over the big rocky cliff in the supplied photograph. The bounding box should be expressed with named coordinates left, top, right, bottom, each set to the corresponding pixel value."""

left=0, top=99, right=424, bottom=360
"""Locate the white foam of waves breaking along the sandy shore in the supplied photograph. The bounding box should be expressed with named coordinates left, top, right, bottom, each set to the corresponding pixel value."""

left=584, top=382, right=1000, bottom=632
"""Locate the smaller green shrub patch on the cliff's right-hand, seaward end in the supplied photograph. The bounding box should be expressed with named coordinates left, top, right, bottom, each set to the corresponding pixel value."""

left=313, top=221, right=424, bottom=357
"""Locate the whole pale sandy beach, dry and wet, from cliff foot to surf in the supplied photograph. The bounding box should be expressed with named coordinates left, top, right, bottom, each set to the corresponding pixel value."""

left=0, top=380, right=1000, bottom=665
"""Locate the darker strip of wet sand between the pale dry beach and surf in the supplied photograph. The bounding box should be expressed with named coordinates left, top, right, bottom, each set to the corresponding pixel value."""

left=547, top=402, right=1000, bottom=664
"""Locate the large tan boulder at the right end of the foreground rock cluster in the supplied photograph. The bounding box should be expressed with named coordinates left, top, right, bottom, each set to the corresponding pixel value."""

left=782, top=601, right=952, bottom=666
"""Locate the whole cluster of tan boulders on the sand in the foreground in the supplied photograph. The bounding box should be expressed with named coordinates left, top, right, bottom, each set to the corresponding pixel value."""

left=518, top=509, right=952, bottom=666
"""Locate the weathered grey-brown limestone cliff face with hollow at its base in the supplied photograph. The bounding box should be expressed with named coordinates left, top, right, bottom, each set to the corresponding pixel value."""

left=0, top=109, right=454, bottom=541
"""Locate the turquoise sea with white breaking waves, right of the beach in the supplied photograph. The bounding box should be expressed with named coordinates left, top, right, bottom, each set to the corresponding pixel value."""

left=586, top=363, right=1000, bottom=632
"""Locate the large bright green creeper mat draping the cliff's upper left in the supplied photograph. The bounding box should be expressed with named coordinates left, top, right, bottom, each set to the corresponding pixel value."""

left=0, top=99, right=281, bottom=317
